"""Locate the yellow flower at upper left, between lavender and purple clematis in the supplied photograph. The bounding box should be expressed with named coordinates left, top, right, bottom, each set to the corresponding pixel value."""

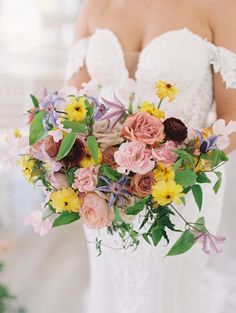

left=65, top=97, right=87, bottom=122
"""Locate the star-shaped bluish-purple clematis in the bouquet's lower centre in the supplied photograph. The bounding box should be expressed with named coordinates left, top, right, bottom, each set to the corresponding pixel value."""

left=96, top=176, right=131, bottom=208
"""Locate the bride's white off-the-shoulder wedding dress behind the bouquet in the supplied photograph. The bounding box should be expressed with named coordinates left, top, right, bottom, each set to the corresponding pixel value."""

left=67, top=28, right=236, bottom=313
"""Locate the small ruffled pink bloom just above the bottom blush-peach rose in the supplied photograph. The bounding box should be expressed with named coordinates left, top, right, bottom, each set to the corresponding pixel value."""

left=72, top=166, right=99, bottom=192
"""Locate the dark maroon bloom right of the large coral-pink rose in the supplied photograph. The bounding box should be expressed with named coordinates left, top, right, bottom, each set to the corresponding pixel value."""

left=163, top=117, right=188, bottom=142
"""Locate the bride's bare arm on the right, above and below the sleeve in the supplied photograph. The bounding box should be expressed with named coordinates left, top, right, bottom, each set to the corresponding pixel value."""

left=209, top=0, right=236, bottom=153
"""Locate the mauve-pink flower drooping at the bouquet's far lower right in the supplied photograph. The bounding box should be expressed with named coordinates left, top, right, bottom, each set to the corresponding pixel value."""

left=195, top=232, right=225, bottom=255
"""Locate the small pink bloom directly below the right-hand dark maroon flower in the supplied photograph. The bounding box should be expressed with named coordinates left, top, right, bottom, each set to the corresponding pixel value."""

left=152, top=141, right=177, bottom=167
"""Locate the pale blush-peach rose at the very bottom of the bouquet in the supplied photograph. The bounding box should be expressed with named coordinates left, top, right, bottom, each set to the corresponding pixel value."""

left=80, top=193, right=110, bottom=229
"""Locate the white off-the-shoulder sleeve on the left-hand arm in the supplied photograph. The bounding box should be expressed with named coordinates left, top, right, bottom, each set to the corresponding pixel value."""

left=65, top=37, right=90, bottom=81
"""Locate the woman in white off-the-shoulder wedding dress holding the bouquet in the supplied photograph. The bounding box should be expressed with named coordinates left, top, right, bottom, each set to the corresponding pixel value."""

left=67, top=0, right=236, bottom=313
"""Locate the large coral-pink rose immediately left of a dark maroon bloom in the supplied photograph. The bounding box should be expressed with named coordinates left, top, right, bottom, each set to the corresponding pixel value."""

left=121, top=112, right=165, bottom=145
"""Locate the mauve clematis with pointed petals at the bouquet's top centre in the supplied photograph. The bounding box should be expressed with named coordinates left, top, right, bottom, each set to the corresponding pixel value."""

left=97, top=94, right=126, bottom=129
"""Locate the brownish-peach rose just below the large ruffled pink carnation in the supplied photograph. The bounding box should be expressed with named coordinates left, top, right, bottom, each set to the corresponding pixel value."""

left=130, top=172, right=155, bottom=198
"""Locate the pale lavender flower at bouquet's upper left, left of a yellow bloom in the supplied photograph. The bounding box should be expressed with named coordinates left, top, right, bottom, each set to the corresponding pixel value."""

left=39, top=91, right=65, bottom=130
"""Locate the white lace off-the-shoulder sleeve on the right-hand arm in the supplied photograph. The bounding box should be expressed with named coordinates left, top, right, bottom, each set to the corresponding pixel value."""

left=211, top=46, right=236, bottom=88
